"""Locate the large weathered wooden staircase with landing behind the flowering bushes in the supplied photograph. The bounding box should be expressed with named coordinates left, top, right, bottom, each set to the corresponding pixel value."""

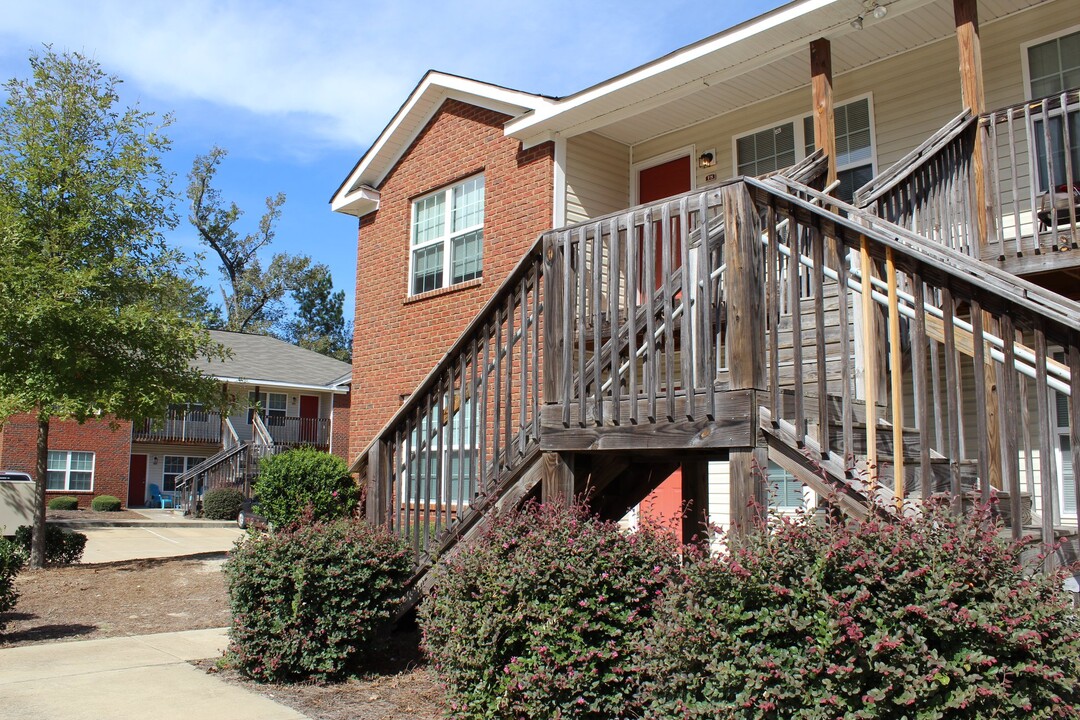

left=360, top=144, right=1080, bottom=600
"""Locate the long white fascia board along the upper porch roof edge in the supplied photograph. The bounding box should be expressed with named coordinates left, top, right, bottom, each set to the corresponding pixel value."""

left=504, top=0, right=841, bottom=142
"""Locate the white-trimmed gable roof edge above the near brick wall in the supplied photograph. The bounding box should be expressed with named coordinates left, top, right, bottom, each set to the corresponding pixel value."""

left=330, top=70, right=553, bottom=217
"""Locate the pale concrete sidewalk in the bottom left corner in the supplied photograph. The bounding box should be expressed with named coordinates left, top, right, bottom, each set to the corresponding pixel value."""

left=0, top=628, right=306, bottom=720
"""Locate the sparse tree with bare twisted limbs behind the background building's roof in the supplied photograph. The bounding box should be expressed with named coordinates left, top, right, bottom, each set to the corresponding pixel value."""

left=188, top=147, right=349, bottom=357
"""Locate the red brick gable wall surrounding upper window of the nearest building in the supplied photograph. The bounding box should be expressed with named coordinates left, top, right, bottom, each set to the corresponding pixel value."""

left=350, top=100, right=554, bottom=454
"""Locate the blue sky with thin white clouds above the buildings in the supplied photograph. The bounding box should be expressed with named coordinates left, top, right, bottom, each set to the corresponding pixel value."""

left=0, top=0, right=782, bottom=317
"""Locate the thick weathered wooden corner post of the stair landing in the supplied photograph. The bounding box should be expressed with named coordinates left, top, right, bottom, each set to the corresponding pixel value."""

left=720, top=182, right=768, bottom=536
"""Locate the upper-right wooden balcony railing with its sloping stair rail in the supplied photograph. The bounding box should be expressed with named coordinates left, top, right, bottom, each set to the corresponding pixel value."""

left=855, top=90, right=1080, bottom=275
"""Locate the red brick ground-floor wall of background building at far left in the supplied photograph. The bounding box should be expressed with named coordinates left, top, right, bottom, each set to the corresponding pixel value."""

left=0, top=415, right=132, bottom=507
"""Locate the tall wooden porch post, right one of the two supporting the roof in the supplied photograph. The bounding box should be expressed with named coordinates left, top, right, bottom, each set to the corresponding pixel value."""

left=953, top=0, right=1002, bottom=488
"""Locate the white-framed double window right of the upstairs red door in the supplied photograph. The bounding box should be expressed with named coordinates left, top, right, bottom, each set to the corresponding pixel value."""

left=733, top=95, right=877, bottom=202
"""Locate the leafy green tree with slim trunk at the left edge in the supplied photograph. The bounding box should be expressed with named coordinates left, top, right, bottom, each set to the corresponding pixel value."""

left=0, top=46, right=222, bottom=567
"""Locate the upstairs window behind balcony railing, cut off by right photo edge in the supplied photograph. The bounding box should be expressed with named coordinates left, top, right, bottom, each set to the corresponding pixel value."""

left=1023, top=28, right=1080, bottom=192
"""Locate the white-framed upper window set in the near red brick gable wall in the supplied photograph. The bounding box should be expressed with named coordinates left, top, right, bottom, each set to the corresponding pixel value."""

left=409, top=175, right=484, bottom=295
